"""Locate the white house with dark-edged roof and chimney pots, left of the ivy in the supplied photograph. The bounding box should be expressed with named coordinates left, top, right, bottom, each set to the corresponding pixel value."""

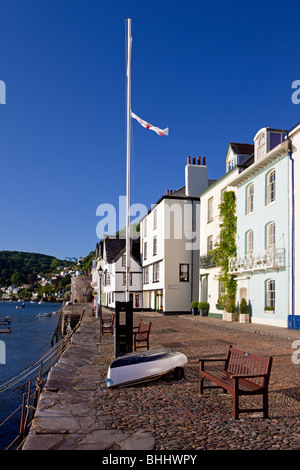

left=140, top=157, right=208, bottom=315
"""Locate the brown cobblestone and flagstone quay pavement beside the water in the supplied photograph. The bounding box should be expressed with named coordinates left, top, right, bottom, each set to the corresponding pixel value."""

left=24, top=309, right=300, bottom=450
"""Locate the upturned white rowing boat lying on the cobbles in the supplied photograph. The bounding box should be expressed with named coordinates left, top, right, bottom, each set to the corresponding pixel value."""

left=105, top=348, right=188, bottom=388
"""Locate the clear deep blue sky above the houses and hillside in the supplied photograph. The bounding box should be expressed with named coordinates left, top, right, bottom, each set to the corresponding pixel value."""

left=0, top=0, right=300, bottom=259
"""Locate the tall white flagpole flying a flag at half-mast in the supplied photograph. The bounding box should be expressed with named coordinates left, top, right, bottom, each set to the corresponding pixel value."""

left=126, top=18, right=132, bottom=302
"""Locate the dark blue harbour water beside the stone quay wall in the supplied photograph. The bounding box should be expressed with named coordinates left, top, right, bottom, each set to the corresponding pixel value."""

left=0, top=301, right=61, bottom=450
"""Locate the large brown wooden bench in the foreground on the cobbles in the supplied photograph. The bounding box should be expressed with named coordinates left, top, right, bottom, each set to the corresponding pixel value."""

left=199, top=346, right=273, bottom=419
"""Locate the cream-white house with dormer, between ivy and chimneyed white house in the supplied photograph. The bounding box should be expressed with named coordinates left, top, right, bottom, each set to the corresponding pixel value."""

left=199, top=143, right=254, bottom=318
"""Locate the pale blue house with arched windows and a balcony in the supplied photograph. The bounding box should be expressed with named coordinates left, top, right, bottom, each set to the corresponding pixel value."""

left=229, top=128, right=290, bottom=327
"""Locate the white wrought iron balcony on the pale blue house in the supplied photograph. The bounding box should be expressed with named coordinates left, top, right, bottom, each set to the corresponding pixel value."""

left=229, top=247, right=285, bottom=274
